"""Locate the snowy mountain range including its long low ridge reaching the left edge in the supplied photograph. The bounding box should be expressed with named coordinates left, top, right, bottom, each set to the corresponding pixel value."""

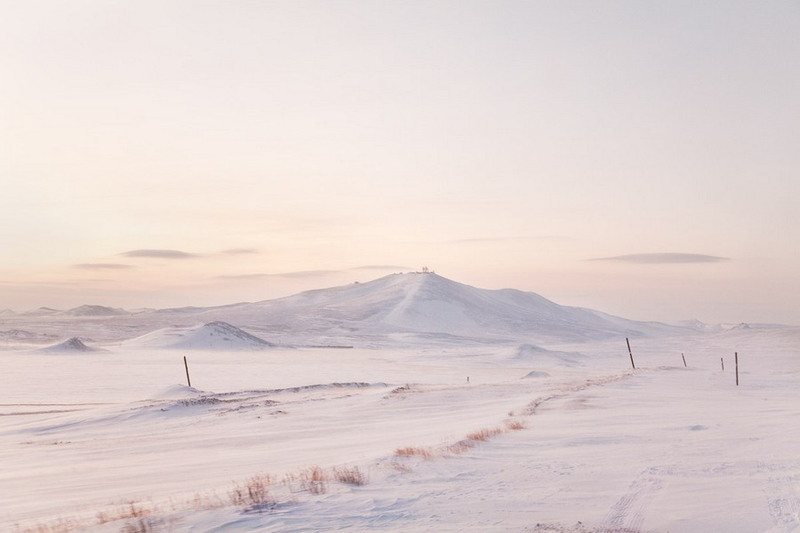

left=4, top=273, right=698, bottom=349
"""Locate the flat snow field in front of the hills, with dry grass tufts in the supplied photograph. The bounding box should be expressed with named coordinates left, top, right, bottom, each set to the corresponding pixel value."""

left=0, top=328, right=800, bottom=533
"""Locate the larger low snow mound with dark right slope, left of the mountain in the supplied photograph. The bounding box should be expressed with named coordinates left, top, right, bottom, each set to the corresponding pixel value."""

left=125, top=321, right=273, bottom=350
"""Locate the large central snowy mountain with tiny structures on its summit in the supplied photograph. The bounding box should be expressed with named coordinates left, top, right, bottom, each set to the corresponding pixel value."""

left=191, top=273, right=682, bottom=342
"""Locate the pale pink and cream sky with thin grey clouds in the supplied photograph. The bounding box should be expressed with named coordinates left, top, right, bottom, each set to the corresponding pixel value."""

left=0, top=0, right=800, bottom=325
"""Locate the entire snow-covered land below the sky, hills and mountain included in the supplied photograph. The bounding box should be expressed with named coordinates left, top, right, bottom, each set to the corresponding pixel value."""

left=0, top=275, right=800, bottom=533
